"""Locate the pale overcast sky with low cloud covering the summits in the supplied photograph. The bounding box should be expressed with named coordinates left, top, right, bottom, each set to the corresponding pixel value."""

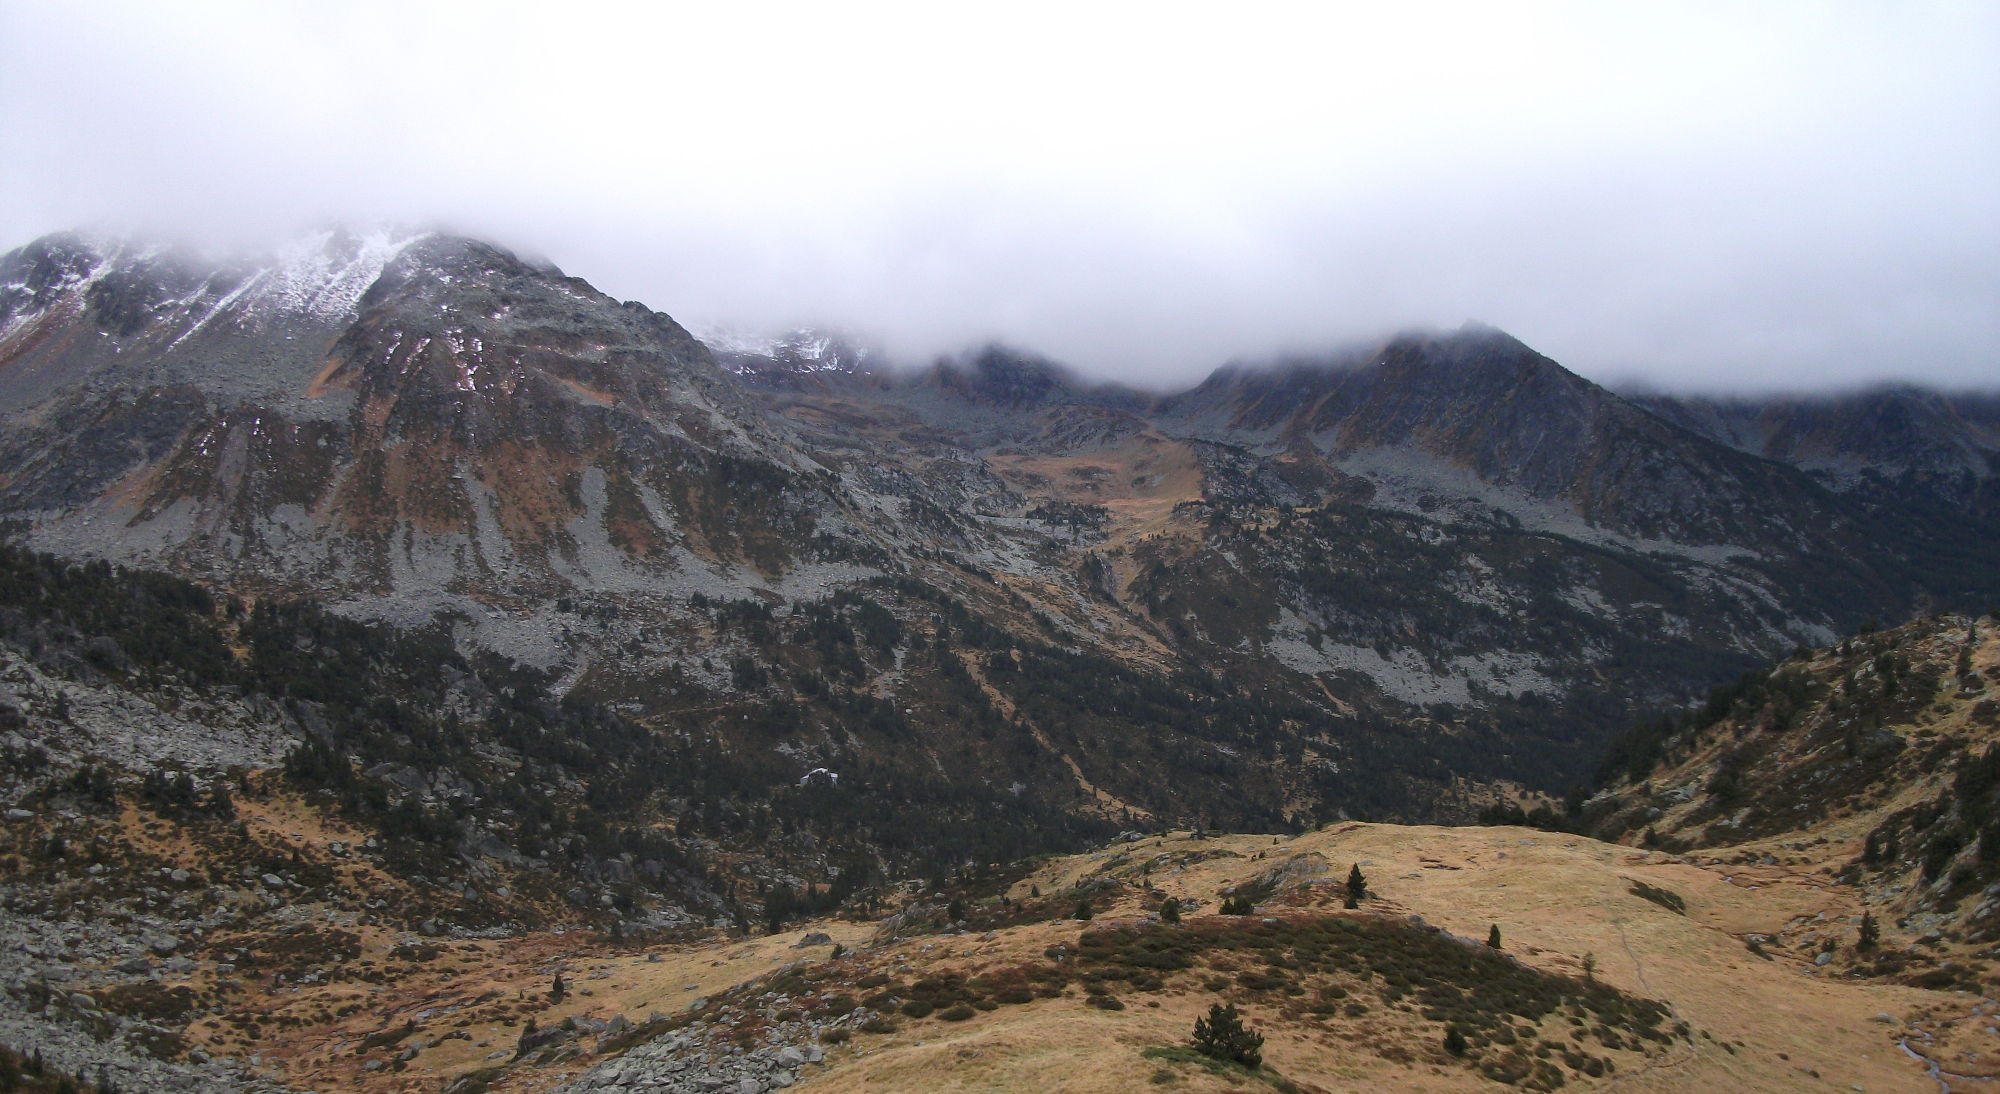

left=0, top=0, right=2000, bottom=390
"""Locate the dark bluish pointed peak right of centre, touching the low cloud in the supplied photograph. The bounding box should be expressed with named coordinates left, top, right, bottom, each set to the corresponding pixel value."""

left=1164, top=328, right=1842, bottom=546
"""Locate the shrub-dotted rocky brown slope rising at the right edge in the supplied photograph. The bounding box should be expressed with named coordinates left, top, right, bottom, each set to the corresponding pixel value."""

left=1580, top=616, right=2000, bottom=964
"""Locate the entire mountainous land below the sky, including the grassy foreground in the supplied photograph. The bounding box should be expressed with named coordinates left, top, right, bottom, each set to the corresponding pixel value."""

left=0, top=230, right=2000, bottom=1094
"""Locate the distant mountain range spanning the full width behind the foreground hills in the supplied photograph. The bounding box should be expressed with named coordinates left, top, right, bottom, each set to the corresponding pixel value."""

left=0, top=232, right=2000, bottom=840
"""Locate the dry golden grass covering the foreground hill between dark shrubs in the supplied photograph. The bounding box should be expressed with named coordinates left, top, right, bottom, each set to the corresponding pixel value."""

left=254, top=824, right=1990, bottom=1094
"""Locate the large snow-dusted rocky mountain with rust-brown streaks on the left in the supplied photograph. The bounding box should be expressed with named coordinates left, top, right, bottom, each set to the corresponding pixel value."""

left=0, top=236, right=860, bottom=644
